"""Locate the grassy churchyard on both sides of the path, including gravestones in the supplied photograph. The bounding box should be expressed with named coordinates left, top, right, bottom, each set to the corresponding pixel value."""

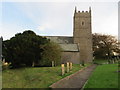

left=2, top=60, right=119, bottom=88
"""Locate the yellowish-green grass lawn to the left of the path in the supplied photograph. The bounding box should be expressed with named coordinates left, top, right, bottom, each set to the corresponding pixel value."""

left=2, top=64, right=89, bottom=88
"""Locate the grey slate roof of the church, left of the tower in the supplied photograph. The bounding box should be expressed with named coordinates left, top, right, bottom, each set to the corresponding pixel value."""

left=46, top=36, right=79, bottom=52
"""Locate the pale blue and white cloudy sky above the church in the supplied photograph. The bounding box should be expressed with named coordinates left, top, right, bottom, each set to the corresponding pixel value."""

left=0, top=0, right=118, bottom=40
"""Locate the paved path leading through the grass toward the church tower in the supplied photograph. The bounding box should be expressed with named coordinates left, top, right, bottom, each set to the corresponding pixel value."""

left=51, top=65, right=97, bottom=89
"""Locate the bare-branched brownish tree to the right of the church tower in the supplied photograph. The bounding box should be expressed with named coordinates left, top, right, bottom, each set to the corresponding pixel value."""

left=93, top=33, right=119, bottom=58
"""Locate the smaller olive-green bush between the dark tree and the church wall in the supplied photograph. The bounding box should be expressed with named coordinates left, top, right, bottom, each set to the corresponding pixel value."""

left=40, top=42, right=61, bottom=66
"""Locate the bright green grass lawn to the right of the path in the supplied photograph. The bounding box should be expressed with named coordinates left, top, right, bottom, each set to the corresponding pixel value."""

left=85, top=64, right=118, bottom=88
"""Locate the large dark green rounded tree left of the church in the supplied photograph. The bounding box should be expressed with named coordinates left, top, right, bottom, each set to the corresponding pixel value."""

left=3, top=30, right=50, bottom=68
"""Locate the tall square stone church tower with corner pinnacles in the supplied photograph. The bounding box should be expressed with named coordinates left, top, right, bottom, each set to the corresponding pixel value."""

left=73, top=7, right=93, bottom=63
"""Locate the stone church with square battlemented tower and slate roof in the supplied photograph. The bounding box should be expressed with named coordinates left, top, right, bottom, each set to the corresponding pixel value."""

left=47, top=7, right=93, bottom=64
